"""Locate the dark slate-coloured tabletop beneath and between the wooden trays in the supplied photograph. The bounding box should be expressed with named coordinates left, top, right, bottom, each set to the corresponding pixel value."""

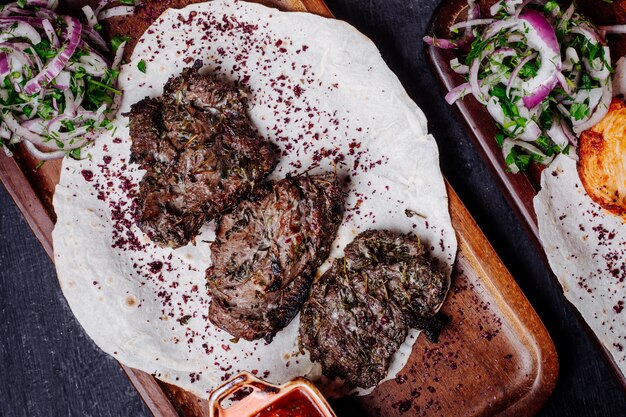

left=0, top=0, right=626, bottom=417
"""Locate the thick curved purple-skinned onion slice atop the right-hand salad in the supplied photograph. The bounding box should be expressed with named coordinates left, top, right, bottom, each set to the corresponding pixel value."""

left=519, top=10, right=561, bottom=109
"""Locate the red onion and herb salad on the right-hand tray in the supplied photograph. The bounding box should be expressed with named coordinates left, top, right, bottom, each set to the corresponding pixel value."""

left=424, top=0, right=622, bottom=173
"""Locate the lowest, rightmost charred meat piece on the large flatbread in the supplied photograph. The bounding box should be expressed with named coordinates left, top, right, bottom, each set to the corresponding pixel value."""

left=300, top=230, right=447, bottom=388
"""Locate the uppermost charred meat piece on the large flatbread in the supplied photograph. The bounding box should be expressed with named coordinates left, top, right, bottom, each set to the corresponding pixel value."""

left=129, top=62, right=278, bottom=247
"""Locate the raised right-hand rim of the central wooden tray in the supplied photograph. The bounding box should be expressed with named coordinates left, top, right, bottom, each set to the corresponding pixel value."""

left=446, top=182, right=559, bottom=416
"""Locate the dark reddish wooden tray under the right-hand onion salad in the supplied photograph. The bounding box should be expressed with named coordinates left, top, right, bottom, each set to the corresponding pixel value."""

left=425, top=0, right=626, bottom=391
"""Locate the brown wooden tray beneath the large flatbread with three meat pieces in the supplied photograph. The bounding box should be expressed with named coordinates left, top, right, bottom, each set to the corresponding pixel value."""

left=0, top=0, right=558, bottom=417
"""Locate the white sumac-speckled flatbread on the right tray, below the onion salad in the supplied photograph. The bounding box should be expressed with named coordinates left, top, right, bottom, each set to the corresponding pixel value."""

left=534, top=155, right=626, bottom=374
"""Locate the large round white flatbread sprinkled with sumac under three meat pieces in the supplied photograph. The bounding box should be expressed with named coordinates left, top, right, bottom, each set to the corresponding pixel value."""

left=53, top=1, right=456, bottom=396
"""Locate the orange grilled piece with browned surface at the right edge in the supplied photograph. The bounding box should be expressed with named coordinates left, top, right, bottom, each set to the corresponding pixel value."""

left=578, top=99, right=626, bottom=218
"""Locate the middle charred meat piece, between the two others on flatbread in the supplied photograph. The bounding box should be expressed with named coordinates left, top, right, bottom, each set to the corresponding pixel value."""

left=207, top=174, right=343, bottom=341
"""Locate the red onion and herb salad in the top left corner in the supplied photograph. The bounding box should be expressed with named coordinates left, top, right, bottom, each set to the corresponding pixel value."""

left=0, top=0, right=135, bottom=161
